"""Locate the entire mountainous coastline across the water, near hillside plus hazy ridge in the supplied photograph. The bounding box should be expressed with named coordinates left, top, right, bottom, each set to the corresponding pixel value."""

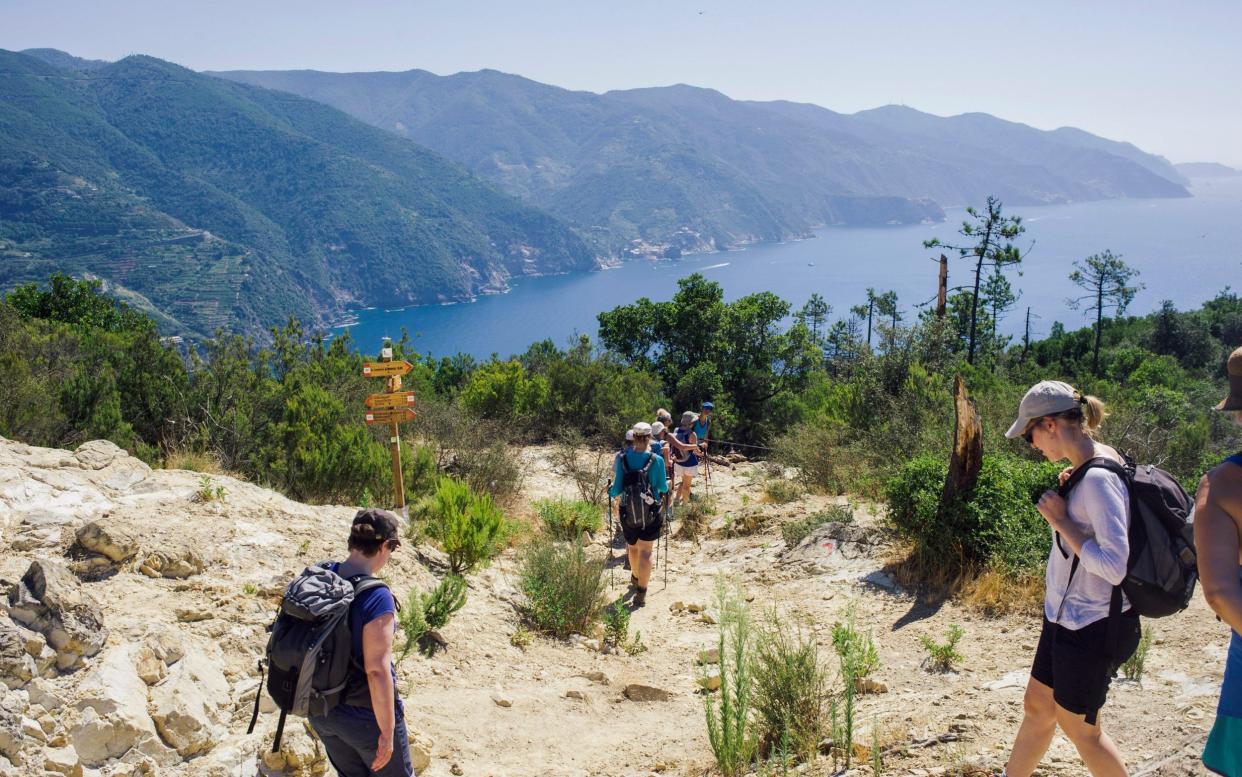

left=0, top=48, right=1189, bottom=335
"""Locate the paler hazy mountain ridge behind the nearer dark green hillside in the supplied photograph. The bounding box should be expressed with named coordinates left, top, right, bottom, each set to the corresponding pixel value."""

left=214, top=70, right=1189, bottom=253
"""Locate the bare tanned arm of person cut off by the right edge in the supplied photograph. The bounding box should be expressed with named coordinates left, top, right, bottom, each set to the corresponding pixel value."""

left=1195, top=468, right=1242, bottom=634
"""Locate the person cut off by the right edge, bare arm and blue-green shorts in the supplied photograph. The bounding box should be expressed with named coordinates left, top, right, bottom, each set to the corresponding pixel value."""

left=1195, top=348, right=1242, bottom=777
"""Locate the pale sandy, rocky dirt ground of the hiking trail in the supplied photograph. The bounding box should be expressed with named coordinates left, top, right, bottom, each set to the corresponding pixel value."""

left=0, top=441, right=1227, bottom=777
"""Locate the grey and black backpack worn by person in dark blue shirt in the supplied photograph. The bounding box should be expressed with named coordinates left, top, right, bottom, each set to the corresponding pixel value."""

left=246, top=562, right=384, bottom=752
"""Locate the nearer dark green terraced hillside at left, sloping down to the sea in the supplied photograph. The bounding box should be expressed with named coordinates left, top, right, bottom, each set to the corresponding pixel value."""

left=0, top=52, right=594, bottom=335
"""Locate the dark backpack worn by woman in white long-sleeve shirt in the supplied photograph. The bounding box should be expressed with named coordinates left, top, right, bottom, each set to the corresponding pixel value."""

left=1057, top=458, right=1199, bottom=618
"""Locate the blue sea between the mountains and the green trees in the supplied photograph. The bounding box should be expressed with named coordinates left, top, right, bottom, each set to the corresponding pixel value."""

left=329, top=177, right=1242, bottom=359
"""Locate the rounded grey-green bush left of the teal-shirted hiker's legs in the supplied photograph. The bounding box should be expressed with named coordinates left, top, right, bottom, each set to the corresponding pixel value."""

left=518, top=539, right=607, bottom=638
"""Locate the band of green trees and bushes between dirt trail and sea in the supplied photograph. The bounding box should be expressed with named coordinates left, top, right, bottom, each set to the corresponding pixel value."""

left=0, top=265, right=1242, bottom=593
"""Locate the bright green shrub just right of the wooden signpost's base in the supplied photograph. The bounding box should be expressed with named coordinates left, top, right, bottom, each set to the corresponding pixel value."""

left=424, top=477, right=508, bottom=575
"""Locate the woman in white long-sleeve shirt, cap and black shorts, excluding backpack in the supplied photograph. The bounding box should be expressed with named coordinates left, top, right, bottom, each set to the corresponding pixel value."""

left=1004, top=381, right=1141, bottom=777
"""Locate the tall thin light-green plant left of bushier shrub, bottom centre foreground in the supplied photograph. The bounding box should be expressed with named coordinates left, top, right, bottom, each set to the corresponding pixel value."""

left=703, top=578, right=759, bottom=777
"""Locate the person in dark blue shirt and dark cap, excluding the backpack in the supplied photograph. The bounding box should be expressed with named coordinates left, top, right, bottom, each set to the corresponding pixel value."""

left=311, top=510, right=414, bottom=777
